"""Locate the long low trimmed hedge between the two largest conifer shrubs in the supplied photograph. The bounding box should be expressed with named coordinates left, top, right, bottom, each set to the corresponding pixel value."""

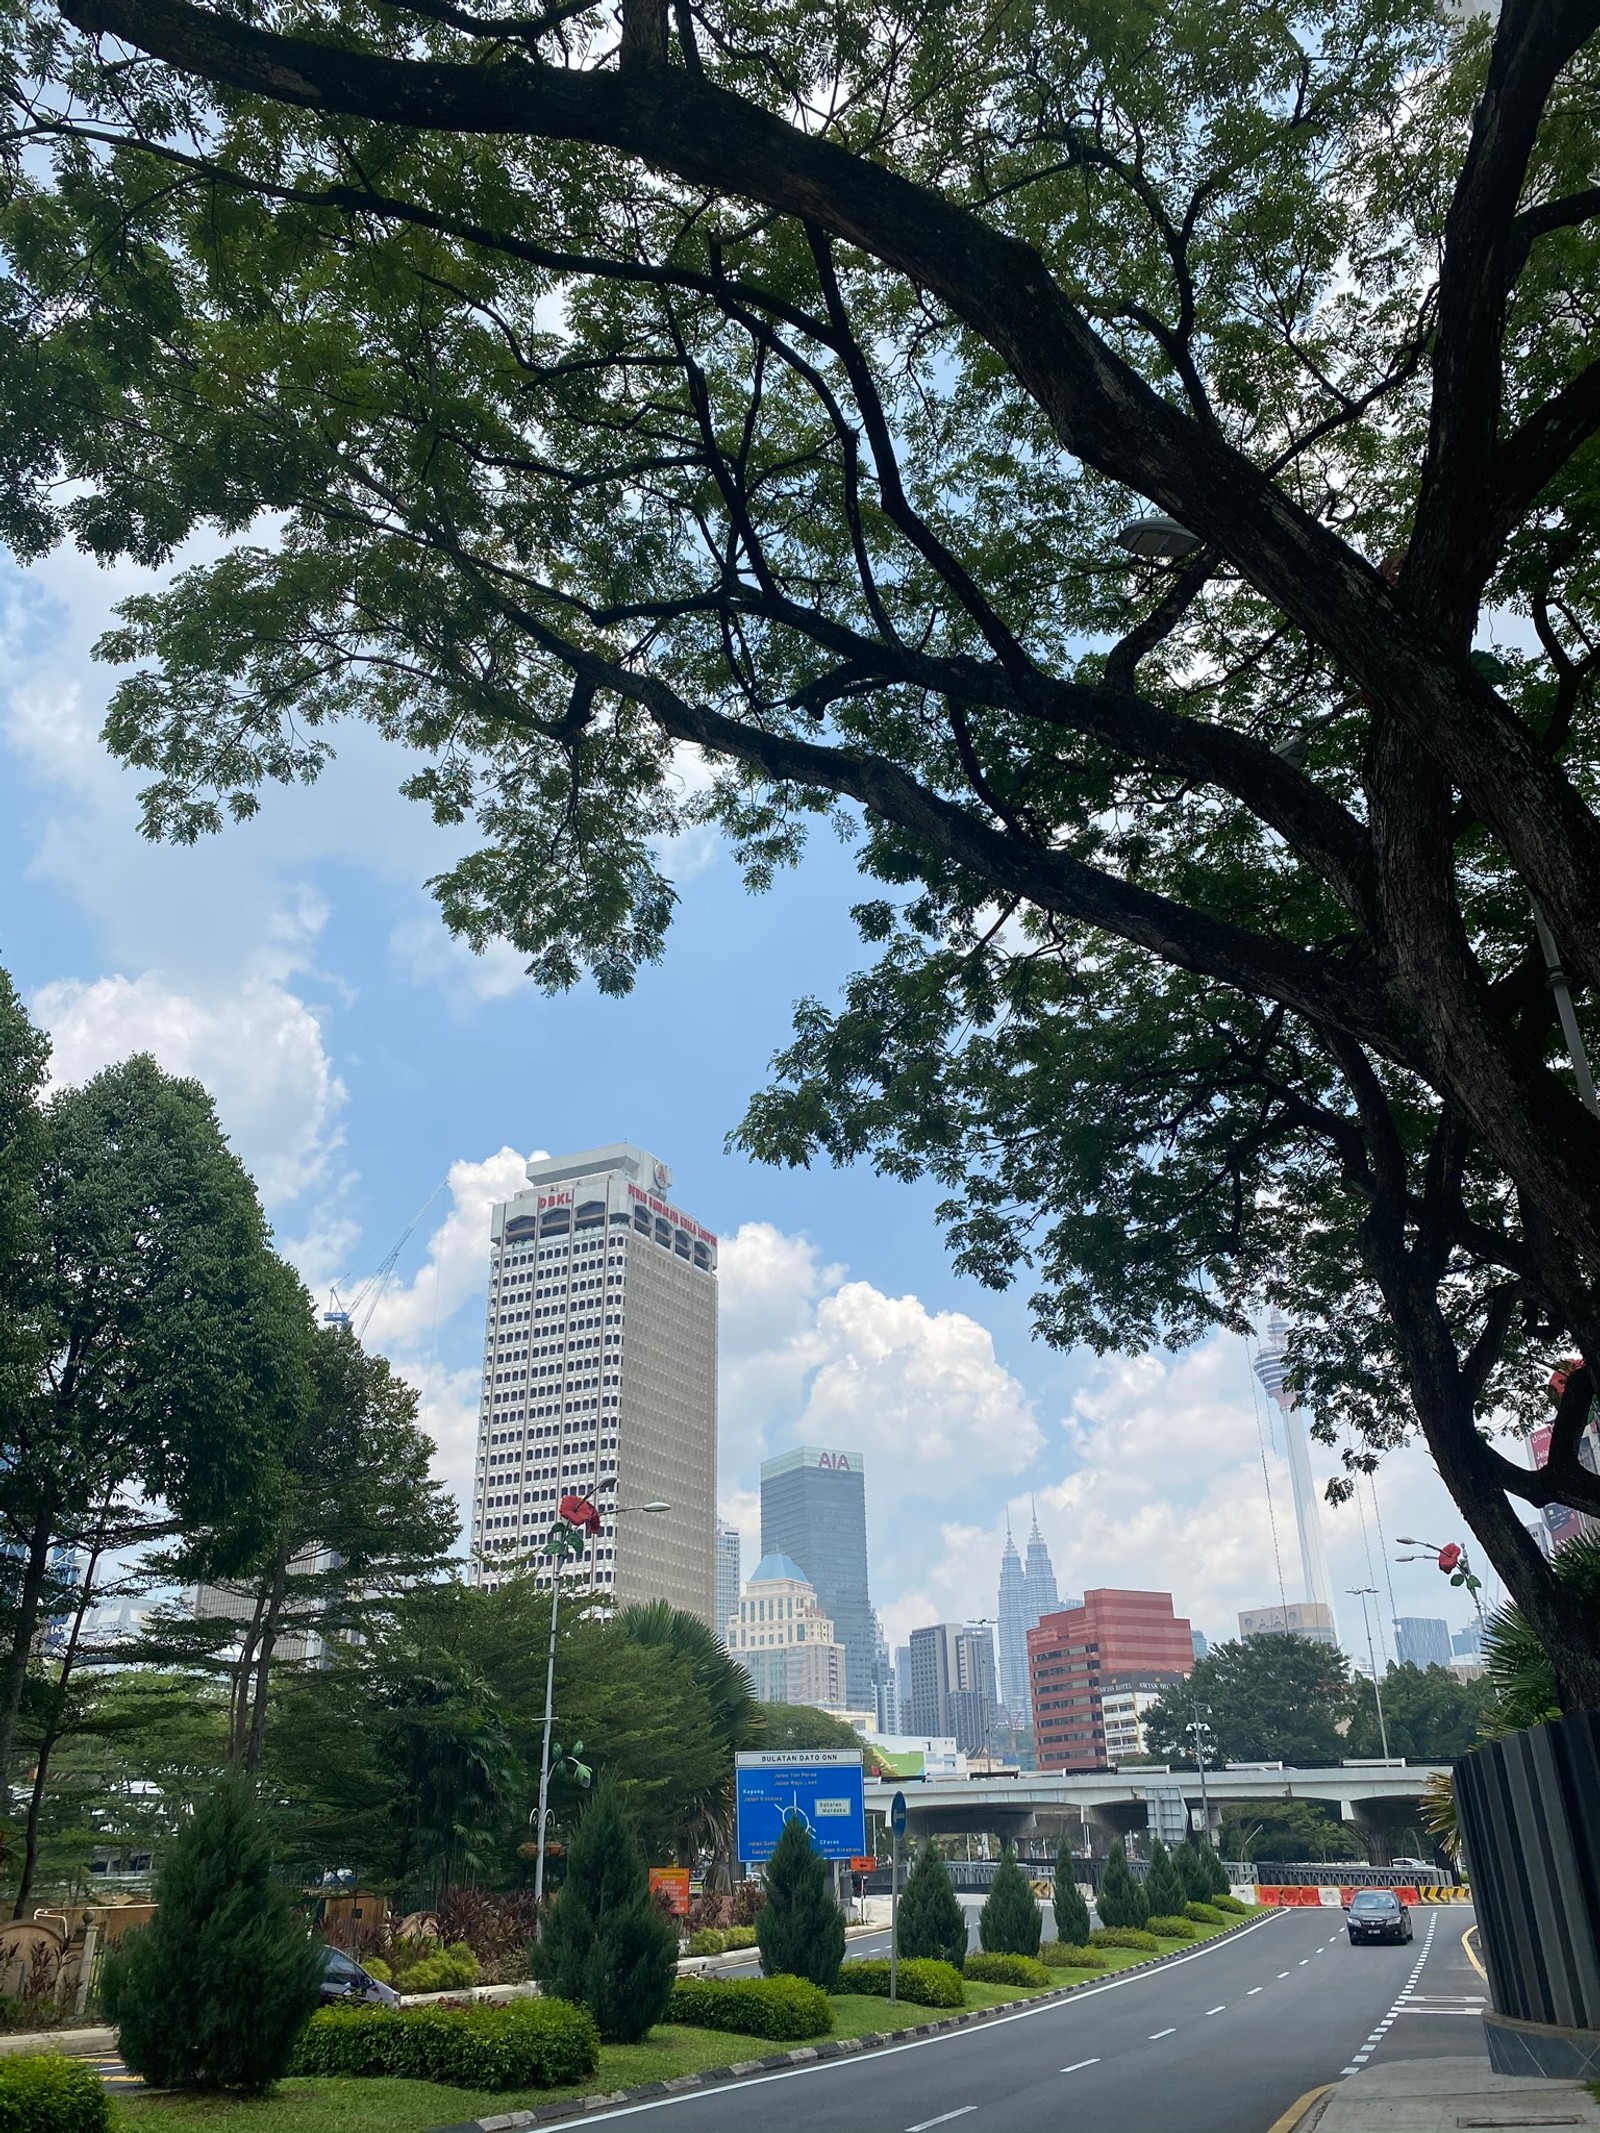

left=292, top=1999, right=599, bottom=2088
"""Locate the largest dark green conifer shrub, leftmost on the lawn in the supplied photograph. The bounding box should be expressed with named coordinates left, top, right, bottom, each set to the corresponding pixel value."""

left=100, top=1777, right=322, bottom=2095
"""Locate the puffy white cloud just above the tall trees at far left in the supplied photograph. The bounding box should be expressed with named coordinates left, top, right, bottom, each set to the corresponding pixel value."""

left=32, top=971, right=346, bottom=1205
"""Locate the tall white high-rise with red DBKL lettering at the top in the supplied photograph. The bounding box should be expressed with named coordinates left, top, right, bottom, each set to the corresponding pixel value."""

left=471, top=1141, right=717, bottom=1623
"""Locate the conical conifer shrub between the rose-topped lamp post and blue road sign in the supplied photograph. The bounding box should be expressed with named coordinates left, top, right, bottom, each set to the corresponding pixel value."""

left=533, top=1777, right=678, bottom=2043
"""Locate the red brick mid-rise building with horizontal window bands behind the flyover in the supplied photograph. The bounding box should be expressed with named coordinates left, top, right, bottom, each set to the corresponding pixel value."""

left=1028, top=1587, right=1195, bottom=1770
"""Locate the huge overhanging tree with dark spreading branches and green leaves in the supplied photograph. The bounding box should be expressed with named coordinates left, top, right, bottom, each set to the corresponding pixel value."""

left=0, top=0, right=1600, bottom=1706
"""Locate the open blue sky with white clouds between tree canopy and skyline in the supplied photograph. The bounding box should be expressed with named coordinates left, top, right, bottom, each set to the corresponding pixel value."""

left=0, top=537, right=1493, bottom=1645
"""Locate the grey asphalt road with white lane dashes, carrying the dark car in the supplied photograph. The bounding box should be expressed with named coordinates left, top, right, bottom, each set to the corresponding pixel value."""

left=558, top=1905, right=1487, bottom=2133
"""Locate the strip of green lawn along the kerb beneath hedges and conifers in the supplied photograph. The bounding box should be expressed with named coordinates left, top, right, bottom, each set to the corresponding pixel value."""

left=117, top=1926, right=1262, bottom=2133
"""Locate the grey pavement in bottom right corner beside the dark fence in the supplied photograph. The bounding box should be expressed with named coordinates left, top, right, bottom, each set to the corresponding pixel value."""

left=1274, top=2058, right=1600, bottom=2133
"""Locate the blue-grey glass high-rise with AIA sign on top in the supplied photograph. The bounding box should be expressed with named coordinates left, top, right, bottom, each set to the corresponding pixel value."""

left=762, top=1444, right=877, bottom=1711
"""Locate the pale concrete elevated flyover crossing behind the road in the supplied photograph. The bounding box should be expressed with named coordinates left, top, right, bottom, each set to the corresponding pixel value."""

left=866, top=1760, right=1449, bottom=1843
